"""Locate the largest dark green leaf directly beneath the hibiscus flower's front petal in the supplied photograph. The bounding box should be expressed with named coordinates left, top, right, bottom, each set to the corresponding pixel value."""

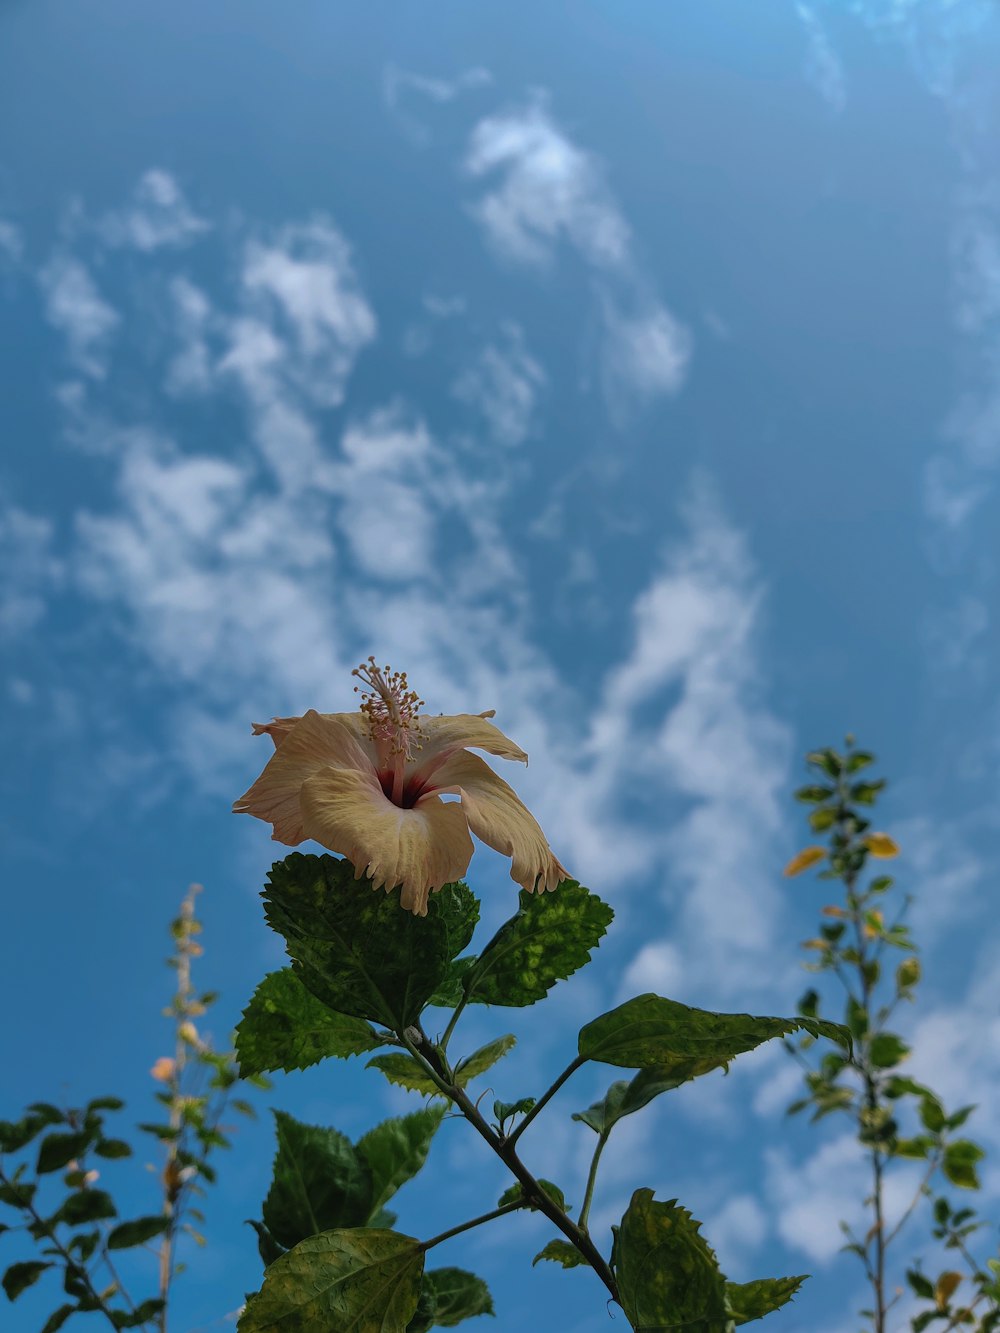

left=264, top=852, right=479, bottom=1032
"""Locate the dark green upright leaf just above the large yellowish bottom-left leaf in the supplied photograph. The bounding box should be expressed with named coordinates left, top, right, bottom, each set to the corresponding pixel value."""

left=264, top=1110, right=372, bottom=1249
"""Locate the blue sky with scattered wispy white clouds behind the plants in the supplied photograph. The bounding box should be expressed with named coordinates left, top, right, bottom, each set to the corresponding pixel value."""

left=0, top=0, right=1000, bottom=1333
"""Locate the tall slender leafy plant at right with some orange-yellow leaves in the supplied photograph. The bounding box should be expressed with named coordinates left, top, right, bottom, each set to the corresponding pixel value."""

left=785, top=737, right=1000, bottom=1333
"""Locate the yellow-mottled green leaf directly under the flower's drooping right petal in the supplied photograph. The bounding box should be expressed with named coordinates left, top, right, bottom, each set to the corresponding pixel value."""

left=467, top=880, right=615, bottom=1008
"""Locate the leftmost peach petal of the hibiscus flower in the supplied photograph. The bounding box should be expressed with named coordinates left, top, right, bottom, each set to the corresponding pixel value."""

left=233, top=709, right=377, bottom=846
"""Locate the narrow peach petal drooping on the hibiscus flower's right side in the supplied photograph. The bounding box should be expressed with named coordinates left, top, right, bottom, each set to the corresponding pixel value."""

left=433, top=750, right=569, bottom=893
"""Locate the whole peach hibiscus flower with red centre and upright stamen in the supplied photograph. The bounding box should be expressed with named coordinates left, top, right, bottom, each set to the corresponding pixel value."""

left=233, top=657, right=567, bottom=916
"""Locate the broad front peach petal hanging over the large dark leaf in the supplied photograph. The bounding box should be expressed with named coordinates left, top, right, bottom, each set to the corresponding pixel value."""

left=301, top=768, right=473, bottom=916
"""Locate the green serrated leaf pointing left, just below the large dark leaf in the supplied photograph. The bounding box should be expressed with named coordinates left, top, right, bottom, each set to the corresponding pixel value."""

left=236, top=968, right=381, bottom=1078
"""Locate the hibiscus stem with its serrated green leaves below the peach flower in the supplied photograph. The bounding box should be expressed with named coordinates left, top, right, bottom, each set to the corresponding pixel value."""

left=236, top=853, right=851, bottom=1333
